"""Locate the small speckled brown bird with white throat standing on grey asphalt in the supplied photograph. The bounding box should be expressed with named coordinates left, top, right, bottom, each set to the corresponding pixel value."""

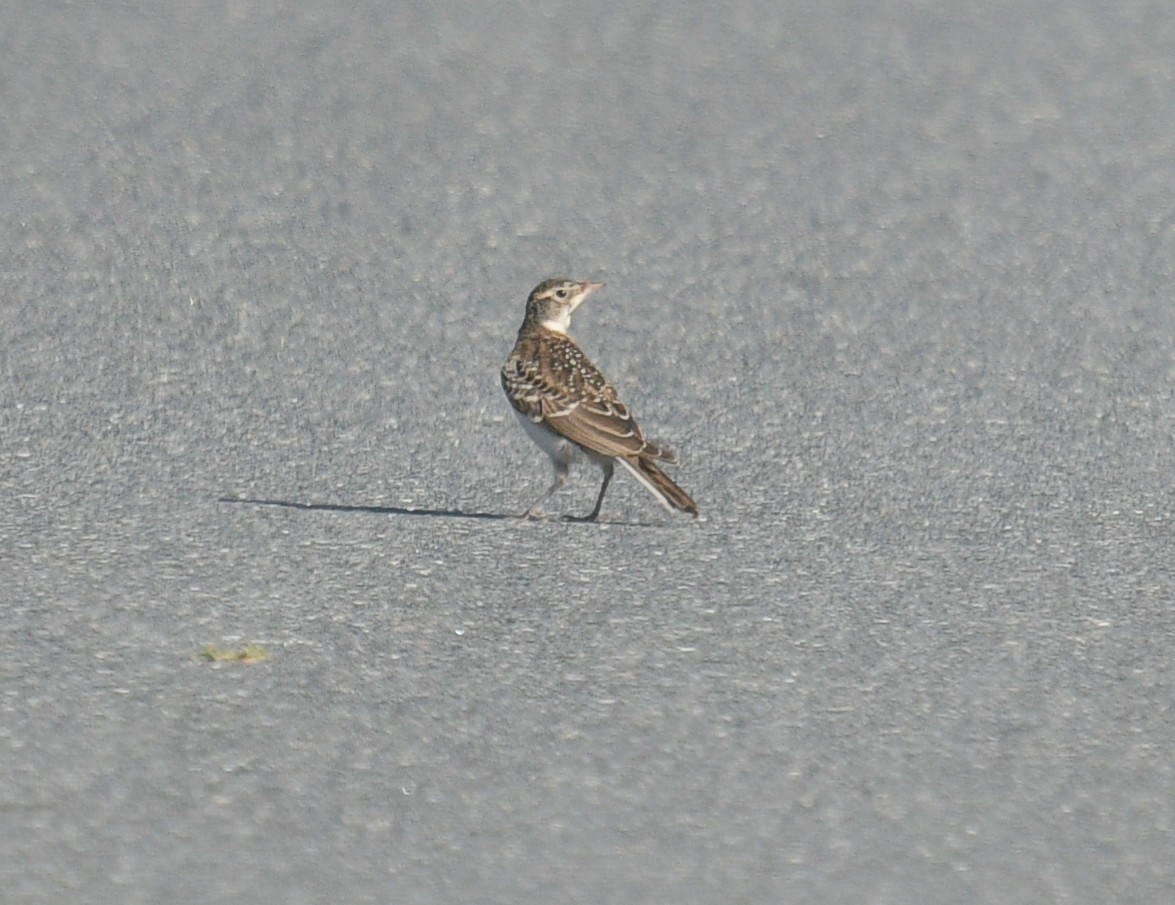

left=502, top=276, right=698, bottom=522
